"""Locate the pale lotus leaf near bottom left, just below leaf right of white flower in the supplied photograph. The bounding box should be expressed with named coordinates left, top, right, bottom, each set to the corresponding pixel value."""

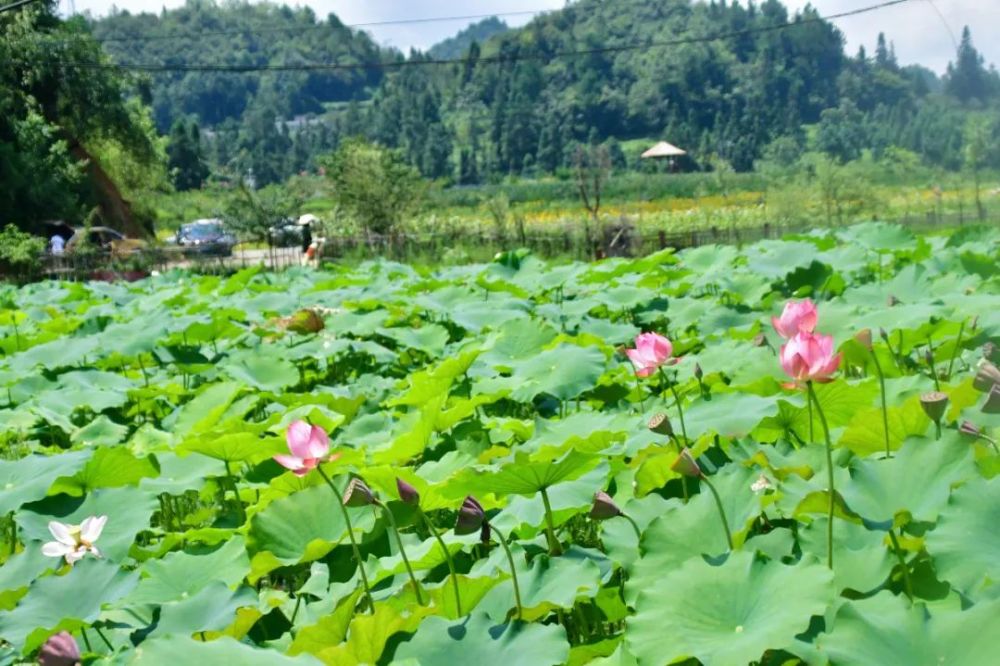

left=149, top=581, right=257, bottom=637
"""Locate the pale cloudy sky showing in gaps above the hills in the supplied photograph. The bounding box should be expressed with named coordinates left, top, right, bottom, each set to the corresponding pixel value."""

left=74, top=0, right=1000, bottom=72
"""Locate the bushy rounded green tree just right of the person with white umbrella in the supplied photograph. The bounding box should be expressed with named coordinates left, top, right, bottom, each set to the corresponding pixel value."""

left=320, top=139, right=425, bottom=234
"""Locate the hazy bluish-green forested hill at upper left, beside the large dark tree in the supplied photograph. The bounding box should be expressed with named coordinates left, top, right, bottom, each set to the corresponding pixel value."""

left=92, top=0, right=390, bottom=132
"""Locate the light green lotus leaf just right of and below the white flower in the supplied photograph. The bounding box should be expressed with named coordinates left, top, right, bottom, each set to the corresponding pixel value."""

left=125, top=536, right=250, bottom=604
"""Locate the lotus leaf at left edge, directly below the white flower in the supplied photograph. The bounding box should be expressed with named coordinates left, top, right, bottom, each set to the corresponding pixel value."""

left=0, top=558, right=139, bottom=652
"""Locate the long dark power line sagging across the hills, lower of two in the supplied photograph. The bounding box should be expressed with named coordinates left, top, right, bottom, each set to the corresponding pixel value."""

left=37, top=0, right=911, bottom=74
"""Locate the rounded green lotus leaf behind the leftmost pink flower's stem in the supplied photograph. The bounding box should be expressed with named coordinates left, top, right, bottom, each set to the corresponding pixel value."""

left=248, top=485, right=375, bottom=564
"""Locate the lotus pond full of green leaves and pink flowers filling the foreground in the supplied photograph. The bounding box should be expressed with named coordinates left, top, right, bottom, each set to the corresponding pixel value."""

left=0, top=223, right=1000, bottom=666
